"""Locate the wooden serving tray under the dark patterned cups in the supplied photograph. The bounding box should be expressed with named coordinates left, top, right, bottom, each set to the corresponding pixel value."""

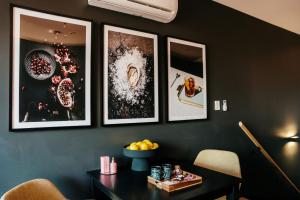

left=148, top=171, right=202, bottom=192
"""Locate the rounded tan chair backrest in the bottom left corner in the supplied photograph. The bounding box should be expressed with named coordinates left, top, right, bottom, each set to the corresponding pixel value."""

left=1, top=179, right=66, bottom=200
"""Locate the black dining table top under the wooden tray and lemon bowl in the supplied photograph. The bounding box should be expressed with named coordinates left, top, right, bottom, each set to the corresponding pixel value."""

left=87, top=162, right=241, bottom=200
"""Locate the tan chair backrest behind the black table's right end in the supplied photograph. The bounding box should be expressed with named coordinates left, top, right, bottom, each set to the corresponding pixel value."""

left=194, top=149, right=242, bottom=178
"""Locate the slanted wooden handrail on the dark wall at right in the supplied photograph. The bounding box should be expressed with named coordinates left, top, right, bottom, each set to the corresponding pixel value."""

left=239, top=121, right=300, bottom=193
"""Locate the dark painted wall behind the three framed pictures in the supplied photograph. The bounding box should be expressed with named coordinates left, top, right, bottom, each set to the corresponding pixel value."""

left=0, top=0, right=300, bottom=199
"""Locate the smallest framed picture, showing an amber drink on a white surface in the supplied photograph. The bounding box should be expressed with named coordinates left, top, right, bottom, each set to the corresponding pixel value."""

left=167, top=37, right=207, bottom=121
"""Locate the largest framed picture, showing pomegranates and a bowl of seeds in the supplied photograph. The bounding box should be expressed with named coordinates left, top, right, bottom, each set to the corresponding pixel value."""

left=10, top=6, right=92, bottom=130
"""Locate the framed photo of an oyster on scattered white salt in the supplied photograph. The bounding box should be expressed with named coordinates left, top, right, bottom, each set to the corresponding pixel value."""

left=103, top=25, right=159, bottom=125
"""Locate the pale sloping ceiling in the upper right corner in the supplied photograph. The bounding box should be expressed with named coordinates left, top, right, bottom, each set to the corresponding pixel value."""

left=214, top=0, right=300, bottom=35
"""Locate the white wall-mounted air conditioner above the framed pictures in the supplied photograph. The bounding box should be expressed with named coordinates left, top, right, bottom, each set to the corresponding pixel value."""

left=88, top=0, right=178, bottom=23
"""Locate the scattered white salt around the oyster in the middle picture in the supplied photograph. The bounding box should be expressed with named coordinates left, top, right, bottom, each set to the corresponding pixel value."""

left=110, top=47, right=147, bottom=105
